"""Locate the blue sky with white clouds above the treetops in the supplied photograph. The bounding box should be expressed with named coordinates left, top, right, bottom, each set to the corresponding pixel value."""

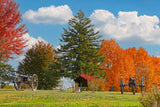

left=11, top=0, right=160, bottom=68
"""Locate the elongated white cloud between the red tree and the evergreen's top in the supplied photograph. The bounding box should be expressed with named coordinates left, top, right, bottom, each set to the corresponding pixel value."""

left=23, top=5, right=73, bottom=24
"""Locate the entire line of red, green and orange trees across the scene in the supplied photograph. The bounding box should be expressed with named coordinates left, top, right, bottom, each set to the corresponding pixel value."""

left=0, top=0, right=160, bottom=91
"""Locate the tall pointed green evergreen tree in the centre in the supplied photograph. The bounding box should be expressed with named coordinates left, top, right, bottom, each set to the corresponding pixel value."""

left=58, top=10, right=104, bottom=78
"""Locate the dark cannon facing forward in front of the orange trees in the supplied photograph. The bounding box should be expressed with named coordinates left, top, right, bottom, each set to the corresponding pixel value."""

left=120, top=77, right=145, bottom=95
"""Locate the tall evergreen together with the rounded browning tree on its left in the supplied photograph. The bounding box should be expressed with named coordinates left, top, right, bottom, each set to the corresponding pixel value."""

left=17, top=11, right=104, bottom=89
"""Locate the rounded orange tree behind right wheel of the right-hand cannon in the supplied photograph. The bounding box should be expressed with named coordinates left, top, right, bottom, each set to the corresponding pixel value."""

left=134, top=47, right=153, bottom=90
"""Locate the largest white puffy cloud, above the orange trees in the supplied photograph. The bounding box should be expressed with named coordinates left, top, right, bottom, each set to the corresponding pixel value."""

left=90, top=10, right=160, bottom=44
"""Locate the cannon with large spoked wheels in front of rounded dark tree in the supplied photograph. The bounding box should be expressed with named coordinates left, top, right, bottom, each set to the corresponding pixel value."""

left=14, top=74, right=38, bottom=91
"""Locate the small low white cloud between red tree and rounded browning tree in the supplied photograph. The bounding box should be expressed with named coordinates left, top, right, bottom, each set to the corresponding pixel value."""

left=14, top=33, right=47, bottom=61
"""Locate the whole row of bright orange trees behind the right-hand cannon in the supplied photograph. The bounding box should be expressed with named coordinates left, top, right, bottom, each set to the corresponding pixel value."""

left=100, top=40, right=156, bottom=91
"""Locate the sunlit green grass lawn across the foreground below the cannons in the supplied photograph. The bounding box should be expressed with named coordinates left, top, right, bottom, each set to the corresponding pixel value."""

left=0, top=90, right=141, bottom=107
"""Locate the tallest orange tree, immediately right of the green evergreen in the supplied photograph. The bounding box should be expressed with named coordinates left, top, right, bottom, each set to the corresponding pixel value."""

left=100, top=40, right=122, bottom=90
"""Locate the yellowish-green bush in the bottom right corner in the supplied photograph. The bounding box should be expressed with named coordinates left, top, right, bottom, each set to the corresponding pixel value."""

left=138, top=87, right=160, bottom=107
